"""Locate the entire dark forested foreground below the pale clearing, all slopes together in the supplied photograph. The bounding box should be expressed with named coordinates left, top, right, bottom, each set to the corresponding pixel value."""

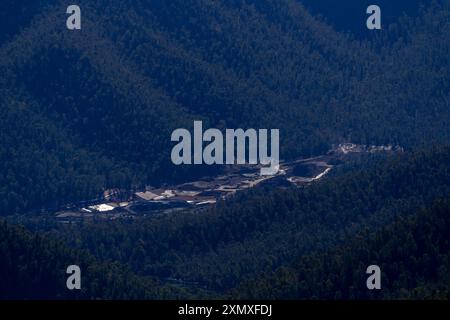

left=4, top=147, right=450, bottom=299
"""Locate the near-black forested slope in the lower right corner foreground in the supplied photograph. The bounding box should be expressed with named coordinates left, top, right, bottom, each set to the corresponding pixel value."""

left=233, top=197, right=450, bottom=299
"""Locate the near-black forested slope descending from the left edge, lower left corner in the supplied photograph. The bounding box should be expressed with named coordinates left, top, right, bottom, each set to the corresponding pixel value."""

left=0, top=221, right=193, bottom=300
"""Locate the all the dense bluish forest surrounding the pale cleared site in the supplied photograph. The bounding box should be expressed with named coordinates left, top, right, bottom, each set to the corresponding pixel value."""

left=0, top=0, right=450, bottom=299
